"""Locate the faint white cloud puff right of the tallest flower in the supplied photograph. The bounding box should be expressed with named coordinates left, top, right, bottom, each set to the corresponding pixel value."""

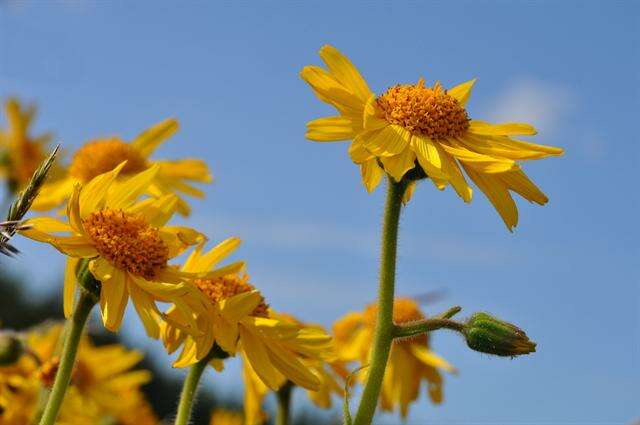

left=489, top=78, right=573, bottom=135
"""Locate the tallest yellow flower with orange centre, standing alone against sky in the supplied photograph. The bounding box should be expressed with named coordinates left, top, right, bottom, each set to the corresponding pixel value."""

left=301, top=46, right=563, bottom=230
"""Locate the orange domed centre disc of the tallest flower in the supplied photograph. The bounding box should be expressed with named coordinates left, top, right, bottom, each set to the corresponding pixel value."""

left=376, top=78, right=469, bottom=140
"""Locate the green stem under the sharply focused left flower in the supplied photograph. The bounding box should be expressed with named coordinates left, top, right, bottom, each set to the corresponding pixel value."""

left=40, top=289, right=96, bottom=425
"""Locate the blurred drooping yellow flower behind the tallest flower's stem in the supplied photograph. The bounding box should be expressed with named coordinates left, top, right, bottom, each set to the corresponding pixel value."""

left=333, top=298, right=455, bottom=418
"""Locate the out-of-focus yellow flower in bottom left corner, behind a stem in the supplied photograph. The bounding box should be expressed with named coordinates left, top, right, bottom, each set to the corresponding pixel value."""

left=0, top=324, right=158, bottom=425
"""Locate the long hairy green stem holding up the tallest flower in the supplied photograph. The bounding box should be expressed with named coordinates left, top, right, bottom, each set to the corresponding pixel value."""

left=353, top=177, right=407, bottom=425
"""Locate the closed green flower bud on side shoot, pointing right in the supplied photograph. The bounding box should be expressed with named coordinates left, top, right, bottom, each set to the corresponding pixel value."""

left=462, top=313, right=536, bottom=357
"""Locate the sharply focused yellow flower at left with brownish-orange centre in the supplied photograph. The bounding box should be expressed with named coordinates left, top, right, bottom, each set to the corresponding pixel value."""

left=22, top=163, right=243, bottom=338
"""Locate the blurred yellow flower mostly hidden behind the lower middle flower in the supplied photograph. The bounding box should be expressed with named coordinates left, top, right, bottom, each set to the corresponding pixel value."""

left=242, top=310, right=349, bottom=425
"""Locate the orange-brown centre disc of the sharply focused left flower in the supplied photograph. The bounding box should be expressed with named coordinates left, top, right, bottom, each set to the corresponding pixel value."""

left=82, top=209, right=169, bottom=280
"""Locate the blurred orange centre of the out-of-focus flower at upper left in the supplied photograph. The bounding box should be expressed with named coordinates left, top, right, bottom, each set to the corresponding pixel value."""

left=69, top=139, right=149, bottom=183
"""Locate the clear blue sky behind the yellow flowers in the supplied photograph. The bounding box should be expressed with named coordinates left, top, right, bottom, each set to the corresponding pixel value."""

left=0, top=1, right=640, bottom=424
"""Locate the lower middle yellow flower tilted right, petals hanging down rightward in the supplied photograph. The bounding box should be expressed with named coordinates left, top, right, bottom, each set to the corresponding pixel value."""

left=161, top=246, right=331, bottom=391
